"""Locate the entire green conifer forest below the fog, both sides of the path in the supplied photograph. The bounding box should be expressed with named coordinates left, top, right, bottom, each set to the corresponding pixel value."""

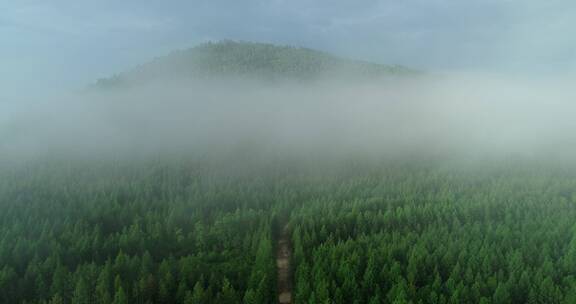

left=0, top=160, right=576, bottom=304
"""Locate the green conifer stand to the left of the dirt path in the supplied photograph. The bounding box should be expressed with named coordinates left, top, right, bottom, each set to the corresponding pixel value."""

left=0, top=162, right=275, bottom=304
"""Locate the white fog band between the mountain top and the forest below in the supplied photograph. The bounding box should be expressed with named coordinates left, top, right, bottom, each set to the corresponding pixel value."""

left=0, top=75, right=576, bottom=164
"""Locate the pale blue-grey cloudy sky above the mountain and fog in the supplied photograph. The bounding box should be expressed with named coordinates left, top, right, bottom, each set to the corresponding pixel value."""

left=0, top=0, right=576, bottom=102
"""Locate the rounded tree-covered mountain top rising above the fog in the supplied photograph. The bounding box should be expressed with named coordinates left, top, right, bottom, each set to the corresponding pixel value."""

left=96, top=41, right=414, bottom=88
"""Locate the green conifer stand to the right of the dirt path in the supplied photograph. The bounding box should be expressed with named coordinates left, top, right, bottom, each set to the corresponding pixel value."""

left=290, top=160, right=576, bottom=303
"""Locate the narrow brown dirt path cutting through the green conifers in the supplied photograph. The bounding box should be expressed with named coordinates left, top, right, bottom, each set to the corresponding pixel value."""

left=276, top=225, right=292, bottom=304
